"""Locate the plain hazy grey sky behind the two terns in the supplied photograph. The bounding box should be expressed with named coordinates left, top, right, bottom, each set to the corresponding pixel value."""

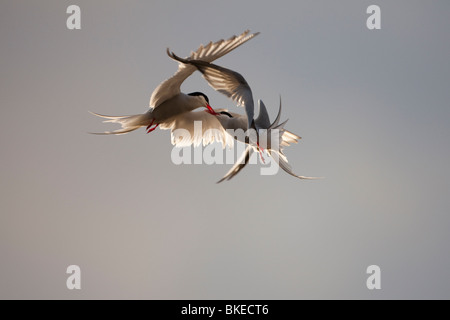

left=0, top=0, right=450, bottom=299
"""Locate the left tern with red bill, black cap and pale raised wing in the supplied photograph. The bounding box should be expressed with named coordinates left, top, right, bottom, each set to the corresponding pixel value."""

left=92, top=30, right=259, bottom=134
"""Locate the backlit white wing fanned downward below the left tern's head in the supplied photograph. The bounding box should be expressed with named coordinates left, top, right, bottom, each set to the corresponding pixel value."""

left=160, top=111, right=234, bottom=148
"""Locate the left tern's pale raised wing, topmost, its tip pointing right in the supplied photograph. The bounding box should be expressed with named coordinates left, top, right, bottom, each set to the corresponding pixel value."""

left=150, top=30, right=259, bottom=108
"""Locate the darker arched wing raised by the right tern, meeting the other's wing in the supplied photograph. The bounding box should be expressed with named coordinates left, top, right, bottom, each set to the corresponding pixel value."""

left=167, top=51, right=254, bottom=128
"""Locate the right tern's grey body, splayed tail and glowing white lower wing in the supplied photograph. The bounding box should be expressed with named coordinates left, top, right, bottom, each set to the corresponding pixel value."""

left=161, top=97, right=320, bottom=183
